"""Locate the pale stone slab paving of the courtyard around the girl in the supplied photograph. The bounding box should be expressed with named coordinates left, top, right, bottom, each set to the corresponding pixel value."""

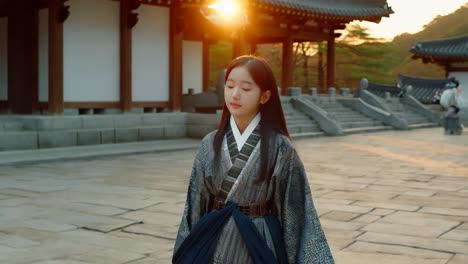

left=0, top=128, right=468, bottom=264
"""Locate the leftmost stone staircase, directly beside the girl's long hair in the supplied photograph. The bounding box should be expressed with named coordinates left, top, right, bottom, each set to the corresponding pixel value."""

left=281, top=97, right=324, bottom=138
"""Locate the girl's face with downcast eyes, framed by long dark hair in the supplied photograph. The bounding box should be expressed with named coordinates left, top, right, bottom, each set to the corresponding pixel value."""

left=224, top=66, right=271, bottom=122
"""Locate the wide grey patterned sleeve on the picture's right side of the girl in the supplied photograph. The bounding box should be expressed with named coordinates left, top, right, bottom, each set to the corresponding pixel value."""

left=275, top=147, right=334, bottom=264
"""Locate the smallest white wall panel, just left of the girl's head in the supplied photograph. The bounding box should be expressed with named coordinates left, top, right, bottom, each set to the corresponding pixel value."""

left=182, top=41, right=203, bottom=94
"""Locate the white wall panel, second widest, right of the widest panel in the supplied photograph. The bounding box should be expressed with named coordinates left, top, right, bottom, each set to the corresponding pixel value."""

left=132, top=5, right=169, bottom=101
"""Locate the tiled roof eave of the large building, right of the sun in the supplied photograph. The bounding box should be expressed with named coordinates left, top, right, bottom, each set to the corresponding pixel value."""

left=252, top=0, right=393, bottom=20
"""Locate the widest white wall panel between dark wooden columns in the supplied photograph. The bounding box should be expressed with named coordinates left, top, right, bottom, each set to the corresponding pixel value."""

left=63, top=0, right=120, bottom=102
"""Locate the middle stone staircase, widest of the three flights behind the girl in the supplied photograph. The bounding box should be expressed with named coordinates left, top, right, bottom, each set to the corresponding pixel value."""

left=312, top=96, right=392, bottom=134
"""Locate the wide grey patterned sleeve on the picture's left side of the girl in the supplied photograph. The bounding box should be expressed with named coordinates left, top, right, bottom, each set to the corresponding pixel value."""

left=174, top=141, right=210, bottom=253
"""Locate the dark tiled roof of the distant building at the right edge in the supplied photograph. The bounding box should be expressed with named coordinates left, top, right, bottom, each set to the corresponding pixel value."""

left=410, top=35, right=468, bottom=61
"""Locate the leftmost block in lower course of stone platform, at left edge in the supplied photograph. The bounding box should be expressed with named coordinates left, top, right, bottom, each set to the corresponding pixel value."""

left=0, top=131, right=38, bottom=150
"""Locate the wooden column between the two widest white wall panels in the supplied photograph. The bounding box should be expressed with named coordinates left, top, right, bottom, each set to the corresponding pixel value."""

left=120, top=0, right=136, bottom=112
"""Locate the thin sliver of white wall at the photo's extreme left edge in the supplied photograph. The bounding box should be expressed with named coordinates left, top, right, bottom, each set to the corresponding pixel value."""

left=0, top=17, right=8, bottom=100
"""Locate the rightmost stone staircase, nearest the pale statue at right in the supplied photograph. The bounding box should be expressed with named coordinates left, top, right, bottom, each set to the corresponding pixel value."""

left=387, top=98, right=438, bottom=128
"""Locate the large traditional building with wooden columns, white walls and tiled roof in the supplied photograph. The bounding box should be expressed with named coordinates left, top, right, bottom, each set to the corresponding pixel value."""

left=0, top=0, right=393, bottom=114
